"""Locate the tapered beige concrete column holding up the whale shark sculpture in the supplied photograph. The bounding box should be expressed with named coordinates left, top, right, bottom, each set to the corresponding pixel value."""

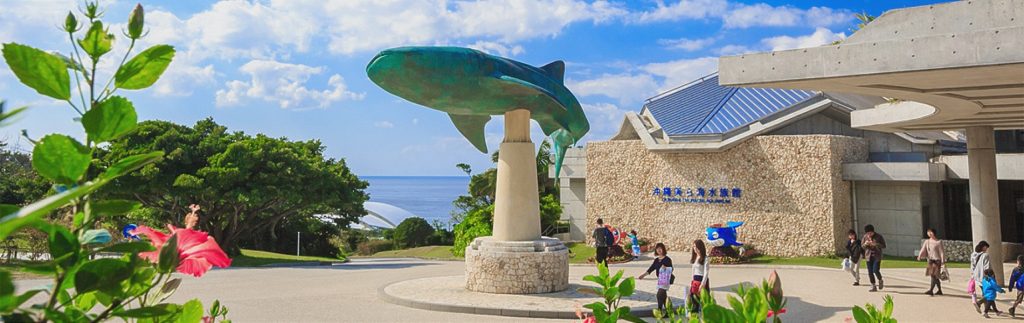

left=494, top=109, right=541, bottom=241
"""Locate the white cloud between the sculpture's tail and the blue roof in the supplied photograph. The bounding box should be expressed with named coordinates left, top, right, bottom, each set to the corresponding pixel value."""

left=566, top=74, right=658, bottom=105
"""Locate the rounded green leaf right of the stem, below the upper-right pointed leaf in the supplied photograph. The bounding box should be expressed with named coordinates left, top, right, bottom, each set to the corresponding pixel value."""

left=82, top=96, right=138, bottom=143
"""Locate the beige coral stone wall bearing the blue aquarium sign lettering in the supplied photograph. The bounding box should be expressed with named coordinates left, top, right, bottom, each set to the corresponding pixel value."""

left=587, top=135, right=867, bottom=256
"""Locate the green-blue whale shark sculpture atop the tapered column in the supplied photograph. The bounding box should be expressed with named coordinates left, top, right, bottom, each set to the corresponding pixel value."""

left=367, top=46, right=590, bottom=177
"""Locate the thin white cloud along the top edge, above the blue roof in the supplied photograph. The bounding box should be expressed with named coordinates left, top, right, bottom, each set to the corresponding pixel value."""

left=722, top=3, right=853, bottom=28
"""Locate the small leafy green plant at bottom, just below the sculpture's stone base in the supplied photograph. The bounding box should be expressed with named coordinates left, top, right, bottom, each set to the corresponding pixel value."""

left=583, top=264, right=643, bottom=323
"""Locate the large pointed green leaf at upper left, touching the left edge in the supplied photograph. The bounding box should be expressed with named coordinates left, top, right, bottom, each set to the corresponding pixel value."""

left=3, top=43, right=71, bottom=100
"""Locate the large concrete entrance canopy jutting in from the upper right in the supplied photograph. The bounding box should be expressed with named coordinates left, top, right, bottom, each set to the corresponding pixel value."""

left=719, top=0, right=1024, bottom=132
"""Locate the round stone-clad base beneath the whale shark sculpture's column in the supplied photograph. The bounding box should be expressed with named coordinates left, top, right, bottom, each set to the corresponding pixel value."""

left=466, top=237, right=569, bottom=294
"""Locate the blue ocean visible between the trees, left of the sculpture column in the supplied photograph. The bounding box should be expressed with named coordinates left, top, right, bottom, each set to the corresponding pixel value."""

left=359, top=176, right=469, bottom=227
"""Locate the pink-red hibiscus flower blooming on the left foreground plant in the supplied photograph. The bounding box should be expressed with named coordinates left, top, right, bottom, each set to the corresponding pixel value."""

left=132, top=225, right=231, bottom=277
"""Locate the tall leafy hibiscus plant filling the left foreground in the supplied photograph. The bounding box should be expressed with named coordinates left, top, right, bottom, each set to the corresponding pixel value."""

left=0, top=2, right=227, bottom=322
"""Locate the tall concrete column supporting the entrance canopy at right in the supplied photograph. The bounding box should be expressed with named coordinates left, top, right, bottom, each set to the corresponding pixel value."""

left=967, top=126, right=1004, bottom=284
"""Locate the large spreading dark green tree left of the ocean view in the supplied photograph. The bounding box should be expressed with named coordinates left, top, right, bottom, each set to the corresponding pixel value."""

left=102, top=119, right=368, bottom=252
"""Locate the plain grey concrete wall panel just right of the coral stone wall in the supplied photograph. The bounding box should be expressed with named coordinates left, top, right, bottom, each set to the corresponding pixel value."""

left=857, top=181, right=925, bottom=256
